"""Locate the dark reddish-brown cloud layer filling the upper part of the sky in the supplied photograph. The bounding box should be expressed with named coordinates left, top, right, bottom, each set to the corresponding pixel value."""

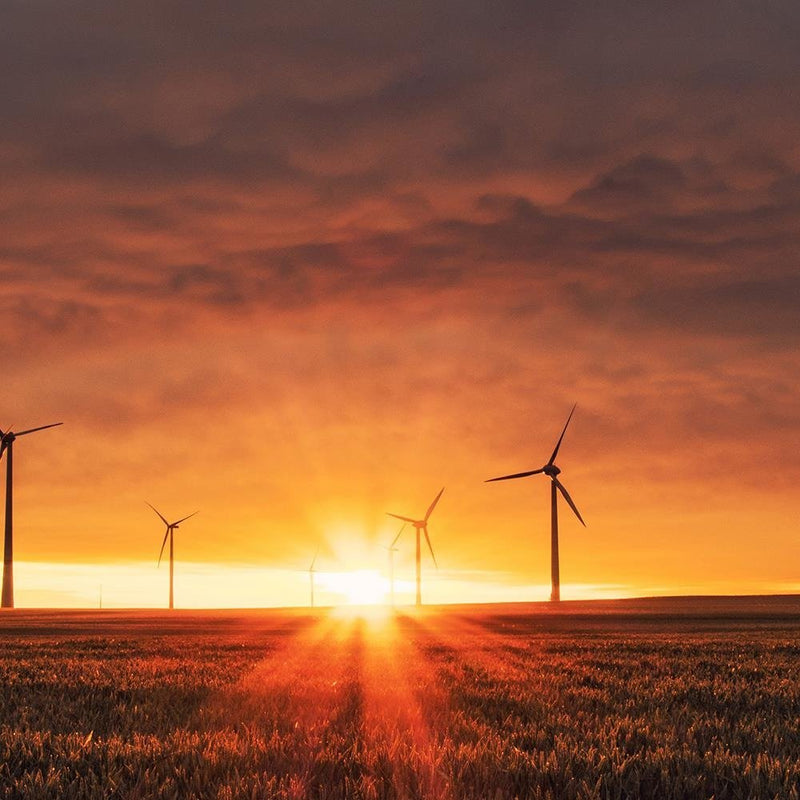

left=0, top=1, right=800, bottom=432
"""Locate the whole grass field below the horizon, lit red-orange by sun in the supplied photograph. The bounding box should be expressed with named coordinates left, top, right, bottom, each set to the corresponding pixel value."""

left=0, top=597, right=800, bottom=800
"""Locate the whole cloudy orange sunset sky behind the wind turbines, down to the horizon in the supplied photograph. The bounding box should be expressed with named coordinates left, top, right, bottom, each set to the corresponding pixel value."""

left=0, top=1, right=800, bottom=605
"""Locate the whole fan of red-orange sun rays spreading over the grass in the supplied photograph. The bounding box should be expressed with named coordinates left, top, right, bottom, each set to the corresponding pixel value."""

left=192, top=606, right=600, bottom=800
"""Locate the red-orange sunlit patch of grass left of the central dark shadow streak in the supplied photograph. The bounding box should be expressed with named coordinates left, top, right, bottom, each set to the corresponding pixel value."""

left=186, top=611, right=363, bottom=797
